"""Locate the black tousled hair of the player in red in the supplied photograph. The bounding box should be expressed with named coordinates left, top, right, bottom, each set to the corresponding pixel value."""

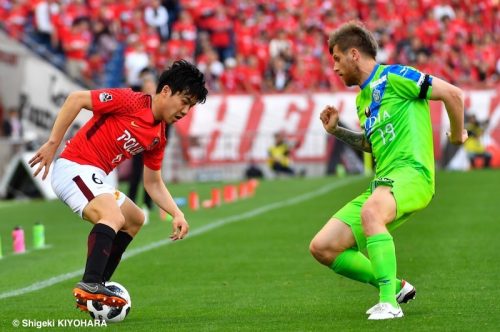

left=156, top=60, right=208, bottom=104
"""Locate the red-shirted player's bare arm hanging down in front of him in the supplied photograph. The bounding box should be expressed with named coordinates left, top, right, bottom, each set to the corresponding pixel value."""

left=144, top=165, right=189, bottom=241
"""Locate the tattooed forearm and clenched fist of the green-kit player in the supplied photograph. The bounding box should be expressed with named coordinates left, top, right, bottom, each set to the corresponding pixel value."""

left=319, top=105, right=372, bottom=152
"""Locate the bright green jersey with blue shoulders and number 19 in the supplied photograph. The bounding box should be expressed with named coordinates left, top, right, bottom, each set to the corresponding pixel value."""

left=356, top=64, right=434, bottom=186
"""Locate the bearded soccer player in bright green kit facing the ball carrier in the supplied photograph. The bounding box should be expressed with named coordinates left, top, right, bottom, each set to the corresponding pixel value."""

left=310, top=22, right=467, bottom=320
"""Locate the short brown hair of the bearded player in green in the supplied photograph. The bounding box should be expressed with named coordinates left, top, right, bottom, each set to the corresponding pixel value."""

left=328, top=21, right=378, bottom=59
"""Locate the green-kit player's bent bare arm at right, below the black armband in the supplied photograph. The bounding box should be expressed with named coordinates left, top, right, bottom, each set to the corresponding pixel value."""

left=431, top=77, right=468, bottom=144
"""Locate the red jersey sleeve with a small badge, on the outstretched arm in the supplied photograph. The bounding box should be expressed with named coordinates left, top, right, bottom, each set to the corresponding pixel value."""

left=90, top=89, right=137, bottom=114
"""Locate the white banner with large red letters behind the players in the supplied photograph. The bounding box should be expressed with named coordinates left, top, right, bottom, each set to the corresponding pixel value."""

left=176, top=90, right=500, bottom=166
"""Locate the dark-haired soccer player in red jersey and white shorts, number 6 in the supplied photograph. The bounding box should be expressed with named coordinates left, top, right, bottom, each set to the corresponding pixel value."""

left=30, top=60, right=207, bottom=310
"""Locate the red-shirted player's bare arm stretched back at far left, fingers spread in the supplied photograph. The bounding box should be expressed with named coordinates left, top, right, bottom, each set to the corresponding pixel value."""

left=29, top=91, right=92, bottom=180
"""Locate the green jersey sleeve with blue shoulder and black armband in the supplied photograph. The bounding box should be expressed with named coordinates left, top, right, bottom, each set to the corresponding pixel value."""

left=387, top=65, right=432, bottom=99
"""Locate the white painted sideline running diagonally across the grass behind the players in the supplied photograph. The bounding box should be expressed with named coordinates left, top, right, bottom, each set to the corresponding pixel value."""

left=0, top=177, right=362, bottom=300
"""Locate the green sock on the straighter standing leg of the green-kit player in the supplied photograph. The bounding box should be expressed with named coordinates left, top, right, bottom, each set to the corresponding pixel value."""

left=366, top=233, right=398, bottom=307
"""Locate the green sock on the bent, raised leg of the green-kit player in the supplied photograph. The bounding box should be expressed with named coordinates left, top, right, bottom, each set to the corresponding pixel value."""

left=331, top=249, right=378, bottom=288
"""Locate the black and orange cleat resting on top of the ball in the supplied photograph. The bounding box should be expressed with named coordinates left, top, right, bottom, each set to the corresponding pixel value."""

left=73, top=281, right=127, bottom=308
